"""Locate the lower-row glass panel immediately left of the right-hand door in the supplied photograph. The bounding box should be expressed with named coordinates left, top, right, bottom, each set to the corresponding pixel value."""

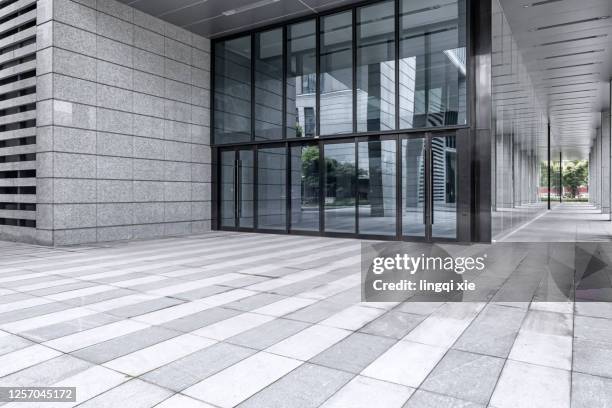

left=357, top=140, right=397, bottom=235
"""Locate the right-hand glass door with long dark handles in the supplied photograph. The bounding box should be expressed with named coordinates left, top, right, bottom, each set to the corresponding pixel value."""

left=400, top=134, right=457, bottom=241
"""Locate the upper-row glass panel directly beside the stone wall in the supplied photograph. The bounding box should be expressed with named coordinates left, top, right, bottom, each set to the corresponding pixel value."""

left=214, top=36, right=251, bottom=143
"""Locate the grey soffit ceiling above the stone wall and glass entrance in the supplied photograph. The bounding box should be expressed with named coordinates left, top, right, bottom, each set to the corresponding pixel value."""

left=120, top=0, right=356, bottom=38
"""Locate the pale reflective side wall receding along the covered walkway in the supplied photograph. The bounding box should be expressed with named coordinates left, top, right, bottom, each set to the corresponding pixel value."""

left=491, top=0, right=547, bottom=238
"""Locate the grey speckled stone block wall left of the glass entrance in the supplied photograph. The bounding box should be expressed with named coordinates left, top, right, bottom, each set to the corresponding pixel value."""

left=36, top=0, right=211, bottom=245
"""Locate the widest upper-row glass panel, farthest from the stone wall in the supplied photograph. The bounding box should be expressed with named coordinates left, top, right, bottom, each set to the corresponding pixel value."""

left=399, top=0, right=466, bottom=129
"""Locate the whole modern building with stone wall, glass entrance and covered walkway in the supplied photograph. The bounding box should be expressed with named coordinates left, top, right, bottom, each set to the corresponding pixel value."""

left=0, top=0, right=612, bottom=245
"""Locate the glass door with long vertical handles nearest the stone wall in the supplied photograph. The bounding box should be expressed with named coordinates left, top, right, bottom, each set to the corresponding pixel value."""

left=220, top=147, right=255, bottom=230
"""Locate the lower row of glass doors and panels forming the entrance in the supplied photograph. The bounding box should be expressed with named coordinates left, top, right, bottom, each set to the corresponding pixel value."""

left=218, top=132, right=458, bottom=241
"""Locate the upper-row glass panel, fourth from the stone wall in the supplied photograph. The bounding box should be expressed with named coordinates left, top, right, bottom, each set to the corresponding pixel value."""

left=320, top=11, right=353, bottom=135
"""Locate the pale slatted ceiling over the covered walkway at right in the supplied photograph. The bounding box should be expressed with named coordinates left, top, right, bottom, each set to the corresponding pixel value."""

left=501, top=0, right=612, bottom=159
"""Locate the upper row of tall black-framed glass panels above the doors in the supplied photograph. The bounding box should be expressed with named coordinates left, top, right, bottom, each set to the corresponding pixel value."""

left=214, top=0, right=467, bottom=144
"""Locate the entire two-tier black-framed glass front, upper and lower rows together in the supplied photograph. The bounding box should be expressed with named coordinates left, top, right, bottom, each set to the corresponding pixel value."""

left=213, top=0, right=468, bottom=239
